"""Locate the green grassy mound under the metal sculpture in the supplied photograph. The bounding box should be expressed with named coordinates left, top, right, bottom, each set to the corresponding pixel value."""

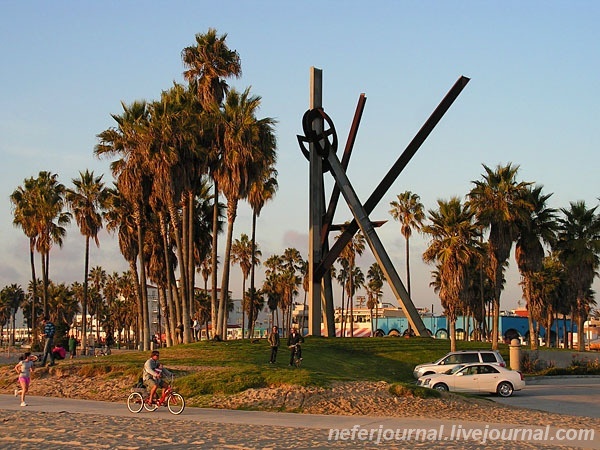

left=88, top=337, right=508, bottom=397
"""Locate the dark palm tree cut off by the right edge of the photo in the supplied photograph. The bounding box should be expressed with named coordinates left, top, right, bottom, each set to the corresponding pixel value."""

left=555, top=201, right=600, bottom=351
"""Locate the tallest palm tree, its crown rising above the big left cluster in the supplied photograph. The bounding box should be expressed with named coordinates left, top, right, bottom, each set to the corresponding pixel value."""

left=181, top=28, right=242, bottom=342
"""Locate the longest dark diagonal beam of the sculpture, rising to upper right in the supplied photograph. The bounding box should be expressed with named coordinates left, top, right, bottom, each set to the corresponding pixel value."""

left=315, top=76, right=469, bottom=279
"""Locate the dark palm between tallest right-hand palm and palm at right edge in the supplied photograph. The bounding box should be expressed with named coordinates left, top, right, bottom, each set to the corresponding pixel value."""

left=515, top=186, right=557, bottom=350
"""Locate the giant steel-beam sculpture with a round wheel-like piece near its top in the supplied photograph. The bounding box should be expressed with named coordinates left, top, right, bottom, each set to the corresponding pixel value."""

left=298, top=67, right=469, bottom=337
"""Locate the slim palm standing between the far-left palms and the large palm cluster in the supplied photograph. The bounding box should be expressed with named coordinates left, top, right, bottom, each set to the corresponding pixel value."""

left=65, top=169, right=108, bottom=348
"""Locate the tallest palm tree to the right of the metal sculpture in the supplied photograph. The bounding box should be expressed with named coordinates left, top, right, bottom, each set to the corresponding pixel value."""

left=468, top=163, right=531, bottom=349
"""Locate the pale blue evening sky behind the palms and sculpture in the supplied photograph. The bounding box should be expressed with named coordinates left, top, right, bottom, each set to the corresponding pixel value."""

left=0, top=0, right=600, bottom=313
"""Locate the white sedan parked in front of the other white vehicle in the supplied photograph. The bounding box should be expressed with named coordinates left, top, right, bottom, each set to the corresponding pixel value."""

left=417, top=364, right=525, bottom=397
